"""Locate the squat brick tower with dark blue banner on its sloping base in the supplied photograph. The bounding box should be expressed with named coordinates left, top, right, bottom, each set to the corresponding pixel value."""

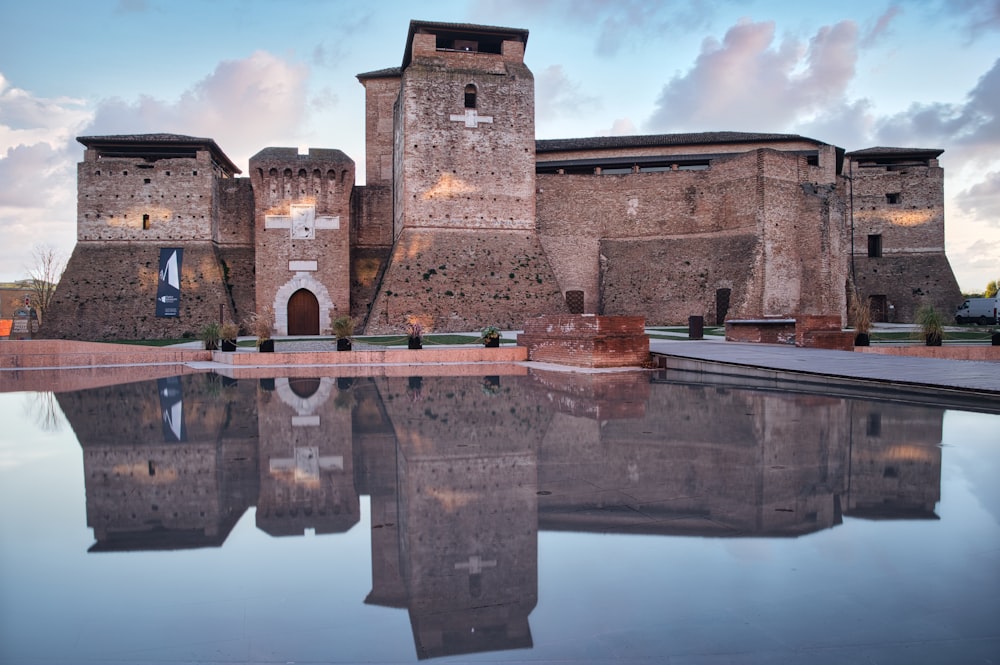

left=42, top=134, right=253, bottom=339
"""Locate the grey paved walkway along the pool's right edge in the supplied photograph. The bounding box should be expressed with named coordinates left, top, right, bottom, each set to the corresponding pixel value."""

left=649, top=339, right=1000, bottom=396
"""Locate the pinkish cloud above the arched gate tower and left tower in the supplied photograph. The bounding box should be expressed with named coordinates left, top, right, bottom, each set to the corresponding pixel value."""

left=87, top=51, right=308, bottom=168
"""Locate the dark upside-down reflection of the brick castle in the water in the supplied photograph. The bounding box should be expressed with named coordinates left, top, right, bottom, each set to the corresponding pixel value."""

left=58, top=370, right=944, bottom=657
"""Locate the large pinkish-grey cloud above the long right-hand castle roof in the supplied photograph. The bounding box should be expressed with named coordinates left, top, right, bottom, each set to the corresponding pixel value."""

left=647, top=20, right=858, bottom=132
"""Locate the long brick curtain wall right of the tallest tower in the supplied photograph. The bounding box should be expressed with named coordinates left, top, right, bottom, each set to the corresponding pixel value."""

left=538, top=149, right=846, bottom=324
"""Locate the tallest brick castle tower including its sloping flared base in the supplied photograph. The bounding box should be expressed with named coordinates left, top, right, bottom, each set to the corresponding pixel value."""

left=359, top=21, right=563, bottom=332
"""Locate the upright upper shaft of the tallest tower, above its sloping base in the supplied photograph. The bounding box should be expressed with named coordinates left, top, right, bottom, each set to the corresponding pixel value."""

left=393, top=21, right=535, bottom=236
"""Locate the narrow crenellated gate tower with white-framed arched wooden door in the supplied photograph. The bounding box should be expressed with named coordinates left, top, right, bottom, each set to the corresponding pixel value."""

left=250, top=148, right=354, bottom=335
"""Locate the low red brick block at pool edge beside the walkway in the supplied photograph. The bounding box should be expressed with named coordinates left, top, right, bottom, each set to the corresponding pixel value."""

left=517, top=314, right=649, bottom=367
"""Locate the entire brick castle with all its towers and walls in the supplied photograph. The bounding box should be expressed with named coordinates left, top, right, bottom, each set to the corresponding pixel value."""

left=43, top=21, right=961, bottom=342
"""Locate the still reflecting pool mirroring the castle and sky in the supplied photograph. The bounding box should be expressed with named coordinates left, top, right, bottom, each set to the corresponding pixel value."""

left=0, top=369, right=1000, bottom=663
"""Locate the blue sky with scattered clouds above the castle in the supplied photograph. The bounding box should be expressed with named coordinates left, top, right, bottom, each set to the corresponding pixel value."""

left=0, top=0, right=1000, bottom=292
